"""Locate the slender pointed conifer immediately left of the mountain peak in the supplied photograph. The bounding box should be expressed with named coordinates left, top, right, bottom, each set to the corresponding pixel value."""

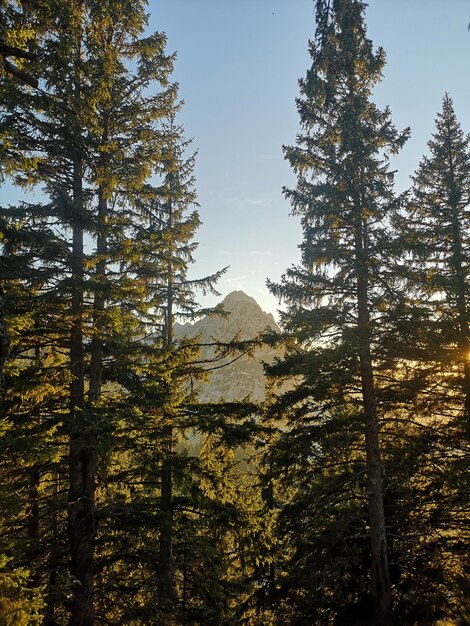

left=90, top=111, right=266, bottom=624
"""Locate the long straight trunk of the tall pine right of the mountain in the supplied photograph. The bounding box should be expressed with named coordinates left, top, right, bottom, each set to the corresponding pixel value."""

left=355, top=217, right=393, bottom=626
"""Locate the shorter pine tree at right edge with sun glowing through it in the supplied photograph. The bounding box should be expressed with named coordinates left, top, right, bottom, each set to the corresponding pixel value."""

left=389, top=95, right=470, bottom=621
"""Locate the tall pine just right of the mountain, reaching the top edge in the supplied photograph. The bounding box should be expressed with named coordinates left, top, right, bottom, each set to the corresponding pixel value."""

left=270, top=0, right=408, bottom=624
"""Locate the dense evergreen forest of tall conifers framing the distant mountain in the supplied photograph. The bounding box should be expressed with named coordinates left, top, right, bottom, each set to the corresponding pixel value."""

left=0, top=0, right=470, bottom=626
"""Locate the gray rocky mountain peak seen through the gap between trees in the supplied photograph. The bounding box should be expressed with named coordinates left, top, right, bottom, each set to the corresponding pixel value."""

left=175, top=291, right=280, bottom=403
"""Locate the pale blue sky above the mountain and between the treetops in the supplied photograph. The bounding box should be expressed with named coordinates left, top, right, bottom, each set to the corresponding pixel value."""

left=149, top=0, right=470, bottom=315
